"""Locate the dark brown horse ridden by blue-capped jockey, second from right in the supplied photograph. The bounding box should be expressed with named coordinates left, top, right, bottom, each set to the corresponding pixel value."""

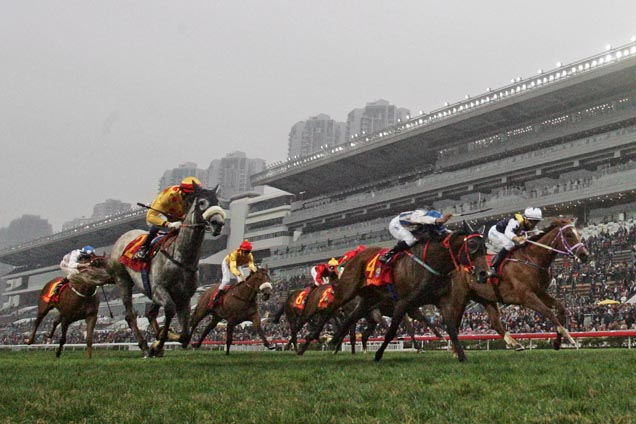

left=298, top=222, right=489, bottom=361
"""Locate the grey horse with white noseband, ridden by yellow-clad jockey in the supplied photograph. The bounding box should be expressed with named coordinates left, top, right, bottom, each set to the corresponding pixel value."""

left=111, top=185, right=225, bottom=357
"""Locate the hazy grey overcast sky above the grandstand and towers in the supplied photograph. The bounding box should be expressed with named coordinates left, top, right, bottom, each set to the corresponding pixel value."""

left=0, top=0, right=636, bottom=230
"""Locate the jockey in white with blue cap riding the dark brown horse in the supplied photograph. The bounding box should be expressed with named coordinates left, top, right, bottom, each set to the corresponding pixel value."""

left=380, top=209, right=453, bottom=264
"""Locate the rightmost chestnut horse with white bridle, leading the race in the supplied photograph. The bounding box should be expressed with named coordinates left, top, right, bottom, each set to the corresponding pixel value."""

left=453, top=218, right=590, bottom=350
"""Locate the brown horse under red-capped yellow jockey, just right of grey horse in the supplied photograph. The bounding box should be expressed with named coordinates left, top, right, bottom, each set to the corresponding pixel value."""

left=190, top=268, right=275, bottom=355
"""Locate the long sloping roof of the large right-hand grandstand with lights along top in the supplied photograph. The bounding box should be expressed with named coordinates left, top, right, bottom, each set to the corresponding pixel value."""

left=252, top=46, right=636, bottom=198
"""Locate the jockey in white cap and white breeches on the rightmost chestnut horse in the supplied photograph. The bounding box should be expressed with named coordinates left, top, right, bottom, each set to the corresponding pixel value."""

left=488, top=207, right=543, bottom=277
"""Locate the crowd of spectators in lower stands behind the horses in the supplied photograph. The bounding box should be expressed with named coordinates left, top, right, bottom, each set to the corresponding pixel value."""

left=0, top=220, right=636, bottom=344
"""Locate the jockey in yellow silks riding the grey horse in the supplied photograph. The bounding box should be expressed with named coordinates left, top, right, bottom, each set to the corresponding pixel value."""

left=135, top=177, right=201, bottom=260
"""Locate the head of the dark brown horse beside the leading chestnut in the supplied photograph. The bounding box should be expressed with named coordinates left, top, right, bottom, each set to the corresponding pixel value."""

left=444, top=221, right=490, bottom=283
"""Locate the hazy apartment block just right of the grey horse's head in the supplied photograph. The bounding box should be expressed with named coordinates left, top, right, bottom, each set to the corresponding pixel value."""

left=207, top=151, right=265, bottom=199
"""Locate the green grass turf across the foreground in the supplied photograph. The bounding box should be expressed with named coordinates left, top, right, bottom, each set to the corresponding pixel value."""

left=0, top=349, right=636, bottom=424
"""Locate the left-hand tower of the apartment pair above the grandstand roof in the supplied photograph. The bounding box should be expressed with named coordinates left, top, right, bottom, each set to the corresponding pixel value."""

left=287, top=113, right=346, bottom=158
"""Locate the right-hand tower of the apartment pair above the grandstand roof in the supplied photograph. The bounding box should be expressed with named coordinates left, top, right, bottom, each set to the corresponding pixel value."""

left=345, top=99, right=410, bottom=140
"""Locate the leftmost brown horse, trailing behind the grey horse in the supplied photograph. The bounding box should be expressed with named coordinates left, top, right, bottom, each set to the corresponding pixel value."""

left=26, top=256, right=115, bottom=359
